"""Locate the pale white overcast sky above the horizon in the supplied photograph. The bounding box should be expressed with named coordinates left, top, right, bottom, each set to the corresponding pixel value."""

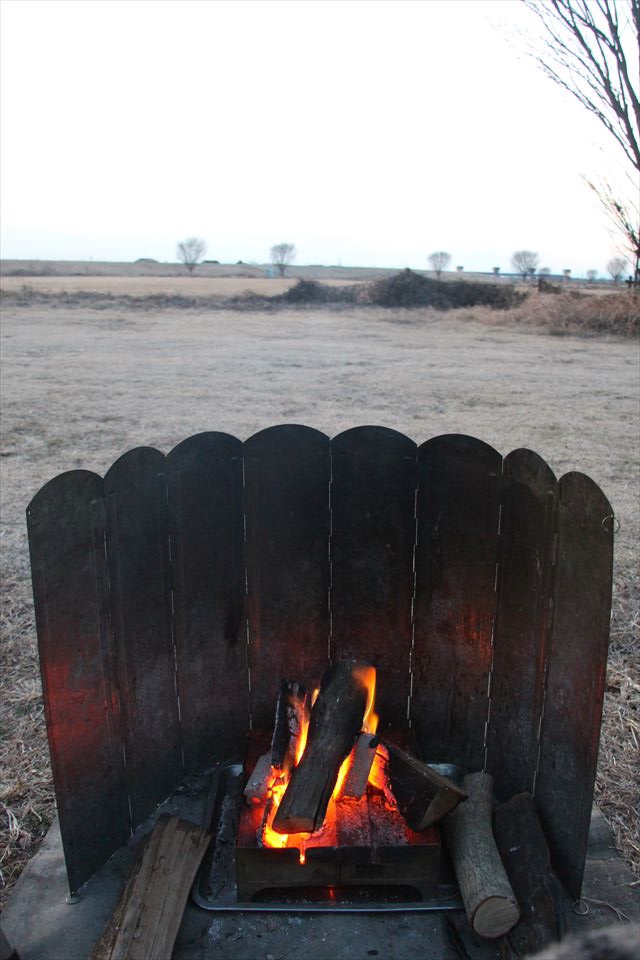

left=0, top=0, right=632, bottom=275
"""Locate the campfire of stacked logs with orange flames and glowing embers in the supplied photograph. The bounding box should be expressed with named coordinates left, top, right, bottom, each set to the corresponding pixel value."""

left=237, top=661, right=466, bottom=899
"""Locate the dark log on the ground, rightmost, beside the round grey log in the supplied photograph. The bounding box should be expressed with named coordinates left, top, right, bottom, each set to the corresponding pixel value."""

left=493, top=793, right=565, bottom=957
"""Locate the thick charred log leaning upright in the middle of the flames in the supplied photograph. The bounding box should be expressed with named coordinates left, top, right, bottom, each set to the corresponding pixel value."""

left=273, top=661, right=370, bottom=834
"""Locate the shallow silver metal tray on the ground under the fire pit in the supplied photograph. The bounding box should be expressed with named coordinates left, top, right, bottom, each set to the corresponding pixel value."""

left=191, top=763, right=462, bottom=913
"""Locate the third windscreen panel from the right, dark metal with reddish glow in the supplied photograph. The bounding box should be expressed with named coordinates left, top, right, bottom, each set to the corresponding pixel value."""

left=411, top=435, right=502, bottom=771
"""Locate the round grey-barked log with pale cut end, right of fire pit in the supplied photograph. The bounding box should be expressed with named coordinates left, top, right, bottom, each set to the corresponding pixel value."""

left=443, top=773, right=520, bottom=940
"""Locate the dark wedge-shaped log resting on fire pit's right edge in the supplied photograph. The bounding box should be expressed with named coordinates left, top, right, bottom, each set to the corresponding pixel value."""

left=371, top=737, right=467, bottom=832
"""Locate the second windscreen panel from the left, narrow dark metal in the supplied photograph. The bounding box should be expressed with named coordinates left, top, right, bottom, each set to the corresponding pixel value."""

left=104, top=447, right=183, bottom=824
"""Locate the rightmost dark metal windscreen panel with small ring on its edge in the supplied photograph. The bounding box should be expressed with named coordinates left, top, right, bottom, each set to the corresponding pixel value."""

left=536, top=473, right=614, bottom=900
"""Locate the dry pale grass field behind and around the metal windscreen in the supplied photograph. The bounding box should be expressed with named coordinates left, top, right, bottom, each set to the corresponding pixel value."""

left=0, top=277, right=640, bottom=908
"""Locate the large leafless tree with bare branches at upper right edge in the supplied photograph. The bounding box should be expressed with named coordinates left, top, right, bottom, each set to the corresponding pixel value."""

left=523, top=0, right=640, bottom=284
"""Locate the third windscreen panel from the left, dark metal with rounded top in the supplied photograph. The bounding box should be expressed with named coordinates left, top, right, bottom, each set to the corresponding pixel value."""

left=167, top=433, right=249, bottom=773
